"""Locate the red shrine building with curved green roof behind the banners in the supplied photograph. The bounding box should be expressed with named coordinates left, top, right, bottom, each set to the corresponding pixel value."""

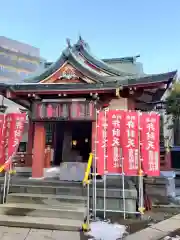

left=0, top=37, right=176, bottom=178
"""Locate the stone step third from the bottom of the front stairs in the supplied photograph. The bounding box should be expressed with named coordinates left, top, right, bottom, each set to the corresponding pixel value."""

left=7, top=193, right=86, bottom=206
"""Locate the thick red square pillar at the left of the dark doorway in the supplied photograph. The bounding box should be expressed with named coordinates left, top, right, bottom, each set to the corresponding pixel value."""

left=32, top=122, right=46, bottom=178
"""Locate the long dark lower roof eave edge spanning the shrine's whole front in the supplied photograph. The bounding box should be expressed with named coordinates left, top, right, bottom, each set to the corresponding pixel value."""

left=0, top=71, right=177, bottom=92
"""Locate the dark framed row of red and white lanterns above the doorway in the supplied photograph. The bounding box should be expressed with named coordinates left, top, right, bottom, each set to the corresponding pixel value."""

left=32, top=101, right=95, bottom=121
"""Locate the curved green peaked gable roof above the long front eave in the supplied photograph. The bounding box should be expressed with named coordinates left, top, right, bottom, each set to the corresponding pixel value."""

left=24, top=36, right=138, bottom=83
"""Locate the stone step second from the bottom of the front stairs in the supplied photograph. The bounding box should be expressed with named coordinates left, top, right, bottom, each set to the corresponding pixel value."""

left=0, top=203, right=86, bottom=222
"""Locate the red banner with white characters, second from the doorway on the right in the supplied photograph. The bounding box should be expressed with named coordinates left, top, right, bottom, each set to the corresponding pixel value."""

left=107, top=110, right=124, bottom=173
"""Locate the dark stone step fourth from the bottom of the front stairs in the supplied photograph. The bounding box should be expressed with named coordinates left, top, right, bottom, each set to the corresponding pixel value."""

left=10, top=184, right=86, bottom=196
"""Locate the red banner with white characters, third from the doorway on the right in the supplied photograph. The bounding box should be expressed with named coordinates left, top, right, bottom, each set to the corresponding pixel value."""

left=123, top=111, right=139, bottom=176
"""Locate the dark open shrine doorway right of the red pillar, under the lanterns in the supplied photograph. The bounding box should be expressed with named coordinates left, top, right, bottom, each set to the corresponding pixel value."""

left=53, top=121, right=92, bottom=166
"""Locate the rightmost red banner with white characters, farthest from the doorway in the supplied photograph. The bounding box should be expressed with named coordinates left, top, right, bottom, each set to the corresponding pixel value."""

left=140, top=113, right=160, bottom=176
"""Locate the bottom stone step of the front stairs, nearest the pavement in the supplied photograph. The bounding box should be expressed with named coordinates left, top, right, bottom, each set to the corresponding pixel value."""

left=0, top=215, right=82, bottom=231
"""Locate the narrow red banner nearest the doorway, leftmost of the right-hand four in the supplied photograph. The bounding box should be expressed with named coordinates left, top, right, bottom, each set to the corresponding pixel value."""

left=96, top=111, right=107, bottom=175
